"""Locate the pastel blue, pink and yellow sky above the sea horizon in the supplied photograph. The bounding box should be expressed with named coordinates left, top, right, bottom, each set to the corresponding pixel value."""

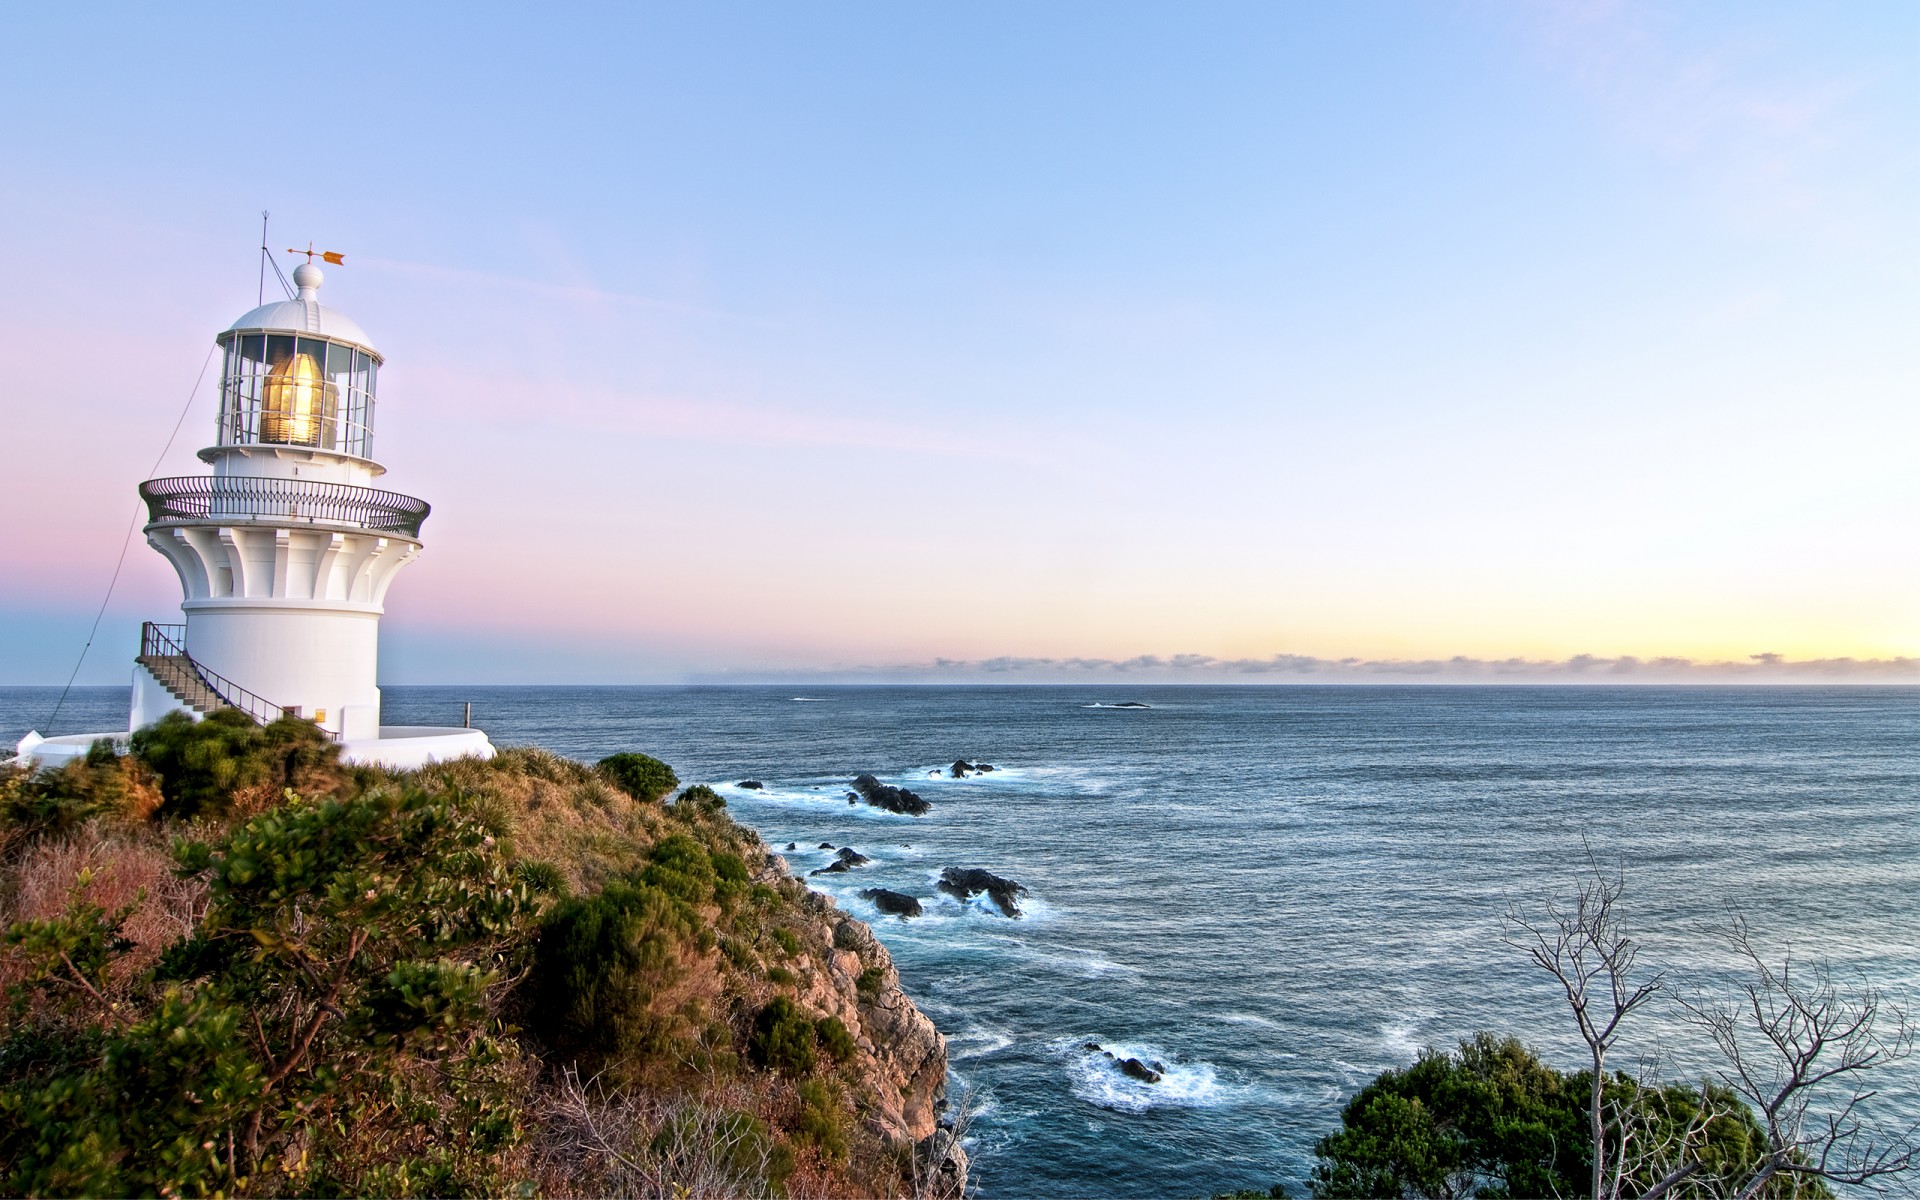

left=0, top=0, right=1920, bottom=684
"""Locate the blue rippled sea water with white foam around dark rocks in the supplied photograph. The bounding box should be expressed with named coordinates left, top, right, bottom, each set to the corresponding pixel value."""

left=0, top=687, right=1920, bottom=1198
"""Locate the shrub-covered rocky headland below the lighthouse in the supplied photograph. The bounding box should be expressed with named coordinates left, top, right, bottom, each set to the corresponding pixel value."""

left=0, top=714, right=964, bottom=1196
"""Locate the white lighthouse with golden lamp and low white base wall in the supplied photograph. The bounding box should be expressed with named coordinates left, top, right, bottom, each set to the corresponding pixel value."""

left=19, top=261, right=493, bottom=768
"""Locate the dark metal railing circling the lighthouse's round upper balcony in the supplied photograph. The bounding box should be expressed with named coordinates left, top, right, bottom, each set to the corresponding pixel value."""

left=140, top=474, right=432, bottom=538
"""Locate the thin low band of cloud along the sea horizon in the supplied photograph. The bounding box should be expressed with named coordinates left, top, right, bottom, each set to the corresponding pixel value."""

left=733, top=653, right=1920, bottom=684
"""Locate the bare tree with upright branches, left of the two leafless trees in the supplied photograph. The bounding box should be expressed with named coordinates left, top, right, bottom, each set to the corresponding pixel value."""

left=1503, top=856, right=1692, bottom=1200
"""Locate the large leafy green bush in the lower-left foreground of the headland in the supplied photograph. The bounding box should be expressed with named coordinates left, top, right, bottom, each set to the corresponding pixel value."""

left=0, top=791, right=532, bottom=1194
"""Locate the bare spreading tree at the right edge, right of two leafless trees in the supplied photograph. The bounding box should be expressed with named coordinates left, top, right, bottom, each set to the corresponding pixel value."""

left=1680, top=918, right=1920, bottom=1200
